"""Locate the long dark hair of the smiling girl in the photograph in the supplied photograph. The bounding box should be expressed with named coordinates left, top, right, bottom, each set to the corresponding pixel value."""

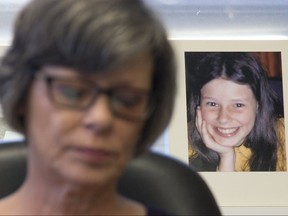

left=186, top=52, right=277, bottom=171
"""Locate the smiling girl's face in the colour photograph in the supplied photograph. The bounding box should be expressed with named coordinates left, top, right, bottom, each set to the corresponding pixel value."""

left=200, top=78, right=258, bottom=146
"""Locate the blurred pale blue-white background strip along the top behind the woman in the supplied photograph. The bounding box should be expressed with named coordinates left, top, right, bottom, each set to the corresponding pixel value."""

left=0, top=0, right=288, bottom=44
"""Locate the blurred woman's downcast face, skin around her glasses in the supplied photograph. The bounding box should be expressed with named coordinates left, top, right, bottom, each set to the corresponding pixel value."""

left=26, top=52, right=153, bottom=185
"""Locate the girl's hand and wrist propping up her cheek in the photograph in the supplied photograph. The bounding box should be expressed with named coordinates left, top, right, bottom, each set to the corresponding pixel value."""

left=196, top=106, right=235, bottom=171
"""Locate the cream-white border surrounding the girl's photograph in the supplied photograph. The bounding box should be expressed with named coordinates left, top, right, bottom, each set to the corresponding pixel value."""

left=168, top=39, right=288, bottom=210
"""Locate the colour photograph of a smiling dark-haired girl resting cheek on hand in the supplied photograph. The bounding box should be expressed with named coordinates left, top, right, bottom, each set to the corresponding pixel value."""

left=185, top=52, right=287, bottom=172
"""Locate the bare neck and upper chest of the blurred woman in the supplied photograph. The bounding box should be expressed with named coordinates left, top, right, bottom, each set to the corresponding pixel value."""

left=0, top=150, right=145, bottom=215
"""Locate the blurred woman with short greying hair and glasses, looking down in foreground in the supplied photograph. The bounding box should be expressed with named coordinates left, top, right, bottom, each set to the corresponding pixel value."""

left=0, top=0, right=175, bottom=215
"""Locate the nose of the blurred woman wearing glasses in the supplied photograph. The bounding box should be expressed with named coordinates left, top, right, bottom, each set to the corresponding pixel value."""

left=84, top=95, right=114, bottom=131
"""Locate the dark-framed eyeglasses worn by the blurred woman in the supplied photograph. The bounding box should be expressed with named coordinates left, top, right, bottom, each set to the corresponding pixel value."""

left=37, top=74, right=154, bottom=121
